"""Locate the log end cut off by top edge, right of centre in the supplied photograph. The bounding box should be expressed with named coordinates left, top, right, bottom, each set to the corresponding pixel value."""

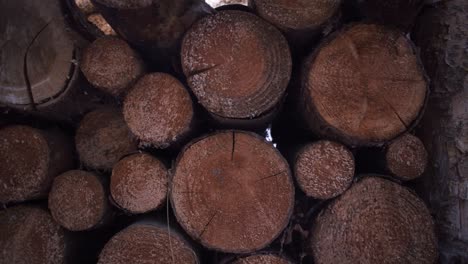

left=251, top=0, right=341, bottom=31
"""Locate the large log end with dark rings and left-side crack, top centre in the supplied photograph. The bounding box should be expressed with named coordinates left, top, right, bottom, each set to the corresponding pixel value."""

left=181, top=10, right=291, bottom=122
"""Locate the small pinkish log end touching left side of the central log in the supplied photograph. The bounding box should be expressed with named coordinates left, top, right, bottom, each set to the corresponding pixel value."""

left=110, top=153, right=168, bottom=214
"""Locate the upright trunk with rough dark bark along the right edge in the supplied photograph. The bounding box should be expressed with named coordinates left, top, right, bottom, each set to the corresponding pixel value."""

left=413, top=0, right=468, bottom=263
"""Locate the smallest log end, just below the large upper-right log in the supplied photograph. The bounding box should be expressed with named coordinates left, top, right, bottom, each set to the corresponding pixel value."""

left=385, top=134, right=428, bottom=180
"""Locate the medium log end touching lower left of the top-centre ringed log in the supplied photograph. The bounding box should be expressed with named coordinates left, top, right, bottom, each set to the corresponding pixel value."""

left=123, top=73, right=194, bottom=148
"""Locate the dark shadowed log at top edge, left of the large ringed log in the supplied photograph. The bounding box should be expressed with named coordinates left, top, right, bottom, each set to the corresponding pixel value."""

left=92, top=0, right=212, bottom=70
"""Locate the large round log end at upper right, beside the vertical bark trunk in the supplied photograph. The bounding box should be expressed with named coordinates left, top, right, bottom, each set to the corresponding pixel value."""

left=299, top=24, right=428, bottom=146
